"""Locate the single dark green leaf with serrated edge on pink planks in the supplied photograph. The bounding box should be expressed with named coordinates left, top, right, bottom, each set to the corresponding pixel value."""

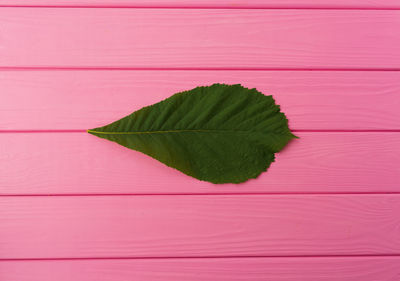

left=88, top=84, right=296, bottom=183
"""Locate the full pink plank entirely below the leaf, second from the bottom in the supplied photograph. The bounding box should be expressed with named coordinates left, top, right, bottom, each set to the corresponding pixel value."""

left=0, top=195, right=400, bottom=259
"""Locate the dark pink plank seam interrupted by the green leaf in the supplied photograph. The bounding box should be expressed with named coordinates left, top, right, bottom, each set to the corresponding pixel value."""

left=0, top=130, right=400, bottom=134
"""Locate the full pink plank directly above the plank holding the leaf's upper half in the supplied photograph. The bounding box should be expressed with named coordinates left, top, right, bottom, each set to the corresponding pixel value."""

left=0, top=8, right=400, bottom=69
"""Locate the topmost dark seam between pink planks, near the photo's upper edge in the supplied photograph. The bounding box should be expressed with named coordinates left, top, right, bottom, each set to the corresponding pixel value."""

left=0, top=4, right=400, bottom=11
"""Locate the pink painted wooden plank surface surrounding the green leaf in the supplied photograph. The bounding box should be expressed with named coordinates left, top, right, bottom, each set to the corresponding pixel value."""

left=0, top=0, right=400, bottom=281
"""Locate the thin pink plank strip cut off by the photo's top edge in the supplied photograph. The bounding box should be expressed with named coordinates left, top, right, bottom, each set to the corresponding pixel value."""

left=1, top=0, right=400, bottom=9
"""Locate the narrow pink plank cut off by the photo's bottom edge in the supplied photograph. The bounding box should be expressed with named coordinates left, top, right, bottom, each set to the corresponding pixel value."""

left=0, top=257, right=400, bottom=281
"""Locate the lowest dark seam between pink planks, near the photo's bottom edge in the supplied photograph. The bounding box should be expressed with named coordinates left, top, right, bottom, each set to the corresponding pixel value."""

left=0, top=254, right=400, bottom=262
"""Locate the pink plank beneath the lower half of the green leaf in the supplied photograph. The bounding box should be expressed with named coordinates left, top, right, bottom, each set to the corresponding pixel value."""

left=0, top=132, right=400, bottom=194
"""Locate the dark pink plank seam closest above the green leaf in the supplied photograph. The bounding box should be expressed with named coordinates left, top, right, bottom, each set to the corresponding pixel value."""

left=0, top=66, right=400, bottom=72
